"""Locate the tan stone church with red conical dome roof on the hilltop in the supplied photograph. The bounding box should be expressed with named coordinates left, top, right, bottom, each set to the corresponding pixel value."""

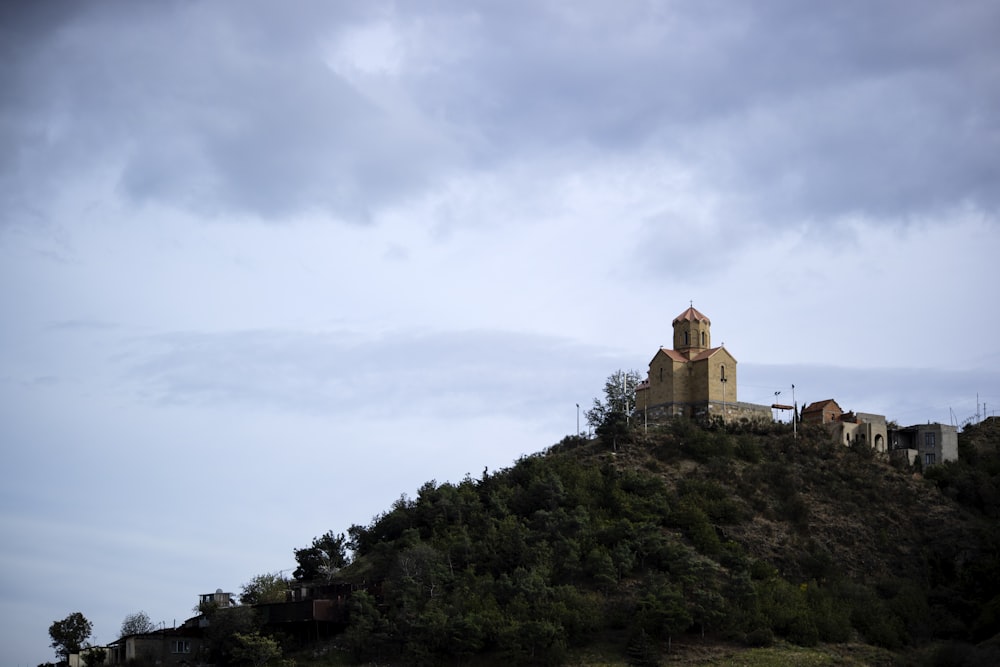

left=635, top=305, right=771, bottom=421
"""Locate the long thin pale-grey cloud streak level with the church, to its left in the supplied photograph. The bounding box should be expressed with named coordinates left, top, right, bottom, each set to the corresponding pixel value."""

left=119, top=331, right=614, bottom=421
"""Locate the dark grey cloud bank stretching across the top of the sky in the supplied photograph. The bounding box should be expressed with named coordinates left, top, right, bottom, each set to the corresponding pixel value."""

left=0, top=0, right=1000, bottom=225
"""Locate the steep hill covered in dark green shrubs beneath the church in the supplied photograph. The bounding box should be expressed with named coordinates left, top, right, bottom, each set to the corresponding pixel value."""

left=298, top=421, right=1000, bottom=665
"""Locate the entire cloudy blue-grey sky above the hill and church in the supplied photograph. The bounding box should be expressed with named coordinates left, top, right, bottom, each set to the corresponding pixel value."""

left=0, top=0, right=1000, bottom=667
